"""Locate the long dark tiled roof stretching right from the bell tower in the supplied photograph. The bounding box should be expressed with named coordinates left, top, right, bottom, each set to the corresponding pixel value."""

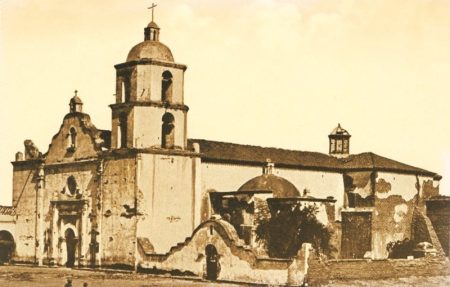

left=188, top=139, right=439, bottom=177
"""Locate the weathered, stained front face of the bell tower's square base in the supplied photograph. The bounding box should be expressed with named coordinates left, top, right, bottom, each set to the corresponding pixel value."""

left=99, top=156, right=136, bottom=266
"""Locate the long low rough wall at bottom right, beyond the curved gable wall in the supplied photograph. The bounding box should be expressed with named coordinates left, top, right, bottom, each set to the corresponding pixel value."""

left=307, top=256, right=450, bottom=286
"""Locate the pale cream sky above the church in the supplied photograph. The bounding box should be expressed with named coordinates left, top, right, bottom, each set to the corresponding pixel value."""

left=0, top=0, right=450, bottom=205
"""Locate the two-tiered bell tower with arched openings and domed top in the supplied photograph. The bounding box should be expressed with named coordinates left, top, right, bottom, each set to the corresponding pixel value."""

left=110, top=20, right=189, bottom=150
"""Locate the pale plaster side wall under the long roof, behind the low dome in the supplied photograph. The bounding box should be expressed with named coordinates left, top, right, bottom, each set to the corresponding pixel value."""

left=200, top=164, right=344, bottom=220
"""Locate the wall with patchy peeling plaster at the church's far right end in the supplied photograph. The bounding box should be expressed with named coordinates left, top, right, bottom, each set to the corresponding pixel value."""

left=372, top=172, right=433, bottom=258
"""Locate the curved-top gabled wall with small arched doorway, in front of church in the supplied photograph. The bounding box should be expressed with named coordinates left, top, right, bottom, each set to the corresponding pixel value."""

left=140, top=220, right=305, bottom=285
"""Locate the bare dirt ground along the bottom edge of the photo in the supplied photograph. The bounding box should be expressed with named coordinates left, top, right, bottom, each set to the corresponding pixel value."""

left=0, top=266, right=450, bottom=287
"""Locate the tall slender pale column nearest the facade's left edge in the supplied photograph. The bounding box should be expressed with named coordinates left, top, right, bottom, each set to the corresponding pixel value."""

left=35, top=164, right=45, bottom=266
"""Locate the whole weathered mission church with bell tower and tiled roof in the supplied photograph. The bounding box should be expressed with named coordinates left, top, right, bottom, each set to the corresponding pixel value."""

left=0, top=9, right=441, bottom=286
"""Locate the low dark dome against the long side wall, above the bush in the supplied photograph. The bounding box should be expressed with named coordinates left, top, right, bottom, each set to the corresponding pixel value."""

left=238, top=174, right=300, bottom=198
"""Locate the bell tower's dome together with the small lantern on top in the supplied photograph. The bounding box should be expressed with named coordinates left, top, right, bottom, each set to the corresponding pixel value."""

left=127, top=20, right=174, bottom=62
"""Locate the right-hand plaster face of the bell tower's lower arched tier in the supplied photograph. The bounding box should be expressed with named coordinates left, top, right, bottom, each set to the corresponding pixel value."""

left=133, top=107, right=186, bottom=148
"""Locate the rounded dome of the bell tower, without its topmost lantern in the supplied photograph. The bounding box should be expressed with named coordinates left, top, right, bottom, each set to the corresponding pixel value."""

left=127, top=40, right=174, bottom=62
